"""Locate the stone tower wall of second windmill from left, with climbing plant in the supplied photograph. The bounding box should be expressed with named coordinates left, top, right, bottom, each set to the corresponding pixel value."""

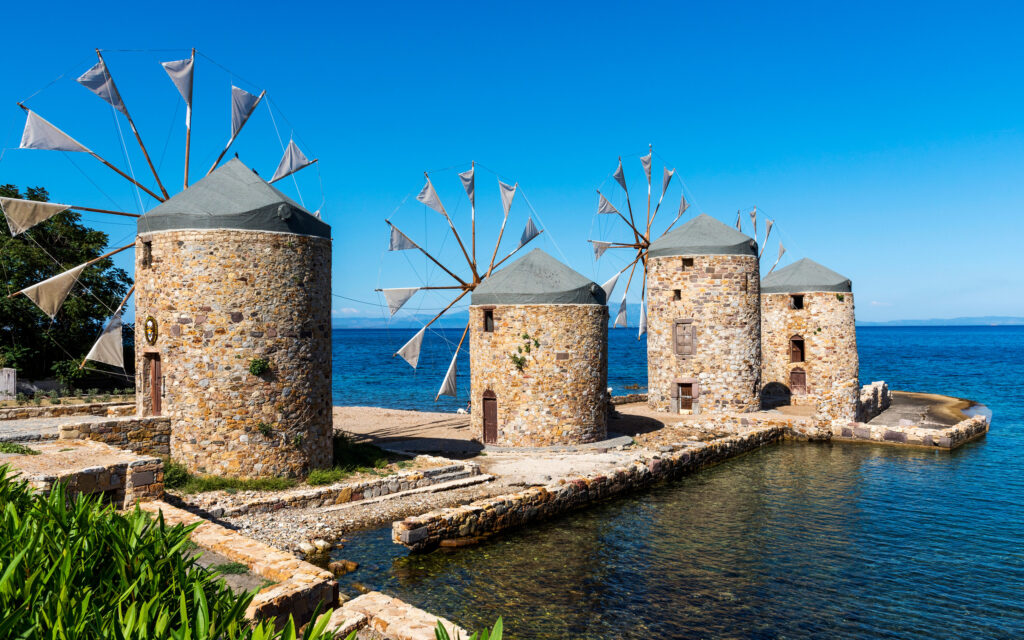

left=469, top=304, right=608, bottom=446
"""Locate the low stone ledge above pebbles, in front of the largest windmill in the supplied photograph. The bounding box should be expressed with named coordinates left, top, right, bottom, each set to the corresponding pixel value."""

left=181, top=456, right=480, bottom=518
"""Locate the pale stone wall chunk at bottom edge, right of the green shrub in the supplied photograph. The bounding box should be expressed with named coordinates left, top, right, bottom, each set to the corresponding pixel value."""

left=328, top=591, right=470, bottom=640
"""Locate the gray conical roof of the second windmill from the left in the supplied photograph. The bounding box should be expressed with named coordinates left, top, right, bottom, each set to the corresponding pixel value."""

left=470, top=249, right=605, bottom=304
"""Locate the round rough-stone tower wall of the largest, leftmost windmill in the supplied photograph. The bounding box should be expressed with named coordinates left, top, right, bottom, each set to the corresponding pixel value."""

left=135, top=229, right=332, bottom=477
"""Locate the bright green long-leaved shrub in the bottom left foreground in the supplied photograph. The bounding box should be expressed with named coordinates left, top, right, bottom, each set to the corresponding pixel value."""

left=0, top=467, right=354, bottom=640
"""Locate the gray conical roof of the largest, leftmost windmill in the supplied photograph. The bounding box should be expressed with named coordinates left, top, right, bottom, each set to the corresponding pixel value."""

left=138, top=159, right=331, bottom=238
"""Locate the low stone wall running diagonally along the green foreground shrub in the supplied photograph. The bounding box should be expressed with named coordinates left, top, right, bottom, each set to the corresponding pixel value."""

left=141, top=501, right=338, bottom=626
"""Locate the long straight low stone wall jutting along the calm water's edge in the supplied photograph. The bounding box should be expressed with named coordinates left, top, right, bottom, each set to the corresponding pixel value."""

left=391, top=427, right=784, bottom=551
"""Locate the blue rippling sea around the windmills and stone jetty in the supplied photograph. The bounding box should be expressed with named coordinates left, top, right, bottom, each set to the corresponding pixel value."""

left=334, top=327, right=1024, bottom=640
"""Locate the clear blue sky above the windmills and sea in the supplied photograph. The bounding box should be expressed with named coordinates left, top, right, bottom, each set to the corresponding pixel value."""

left=0, top=2, right=1024, bottom=324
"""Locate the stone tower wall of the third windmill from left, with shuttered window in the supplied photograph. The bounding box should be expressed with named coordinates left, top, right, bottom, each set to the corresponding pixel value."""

left=647, top=255, right=761, bottom=413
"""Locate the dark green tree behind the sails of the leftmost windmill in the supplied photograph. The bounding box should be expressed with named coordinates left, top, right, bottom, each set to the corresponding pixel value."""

left=0, top=184, right=131, bottom=378
